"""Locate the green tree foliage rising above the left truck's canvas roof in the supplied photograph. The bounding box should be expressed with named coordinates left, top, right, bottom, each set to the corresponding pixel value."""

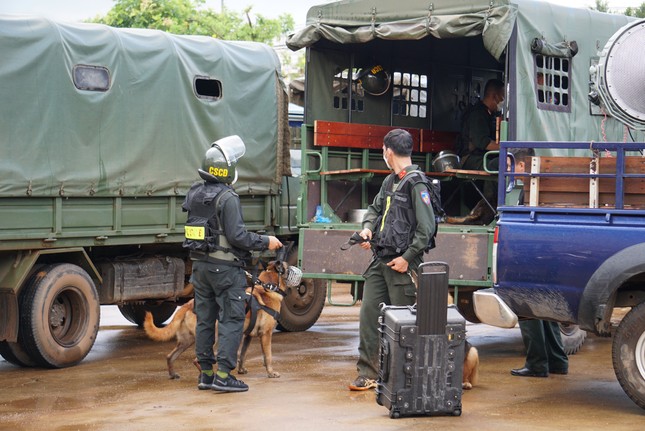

left=90, top=0, right=294, bottom=43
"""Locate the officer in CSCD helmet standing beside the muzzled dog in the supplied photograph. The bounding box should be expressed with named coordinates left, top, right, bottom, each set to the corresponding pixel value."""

left=182, top=135, right=282, bottom=392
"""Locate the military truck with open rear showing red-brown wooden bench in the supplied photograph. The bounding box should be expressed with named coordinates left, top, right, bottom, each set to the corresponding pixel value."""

left=287, top=0, right=643, bottom=352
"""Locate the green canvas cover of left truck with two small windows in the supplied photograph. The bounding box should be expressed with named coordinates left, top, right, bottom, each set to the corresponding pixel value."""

left=0, top=16, right=289, bottom=197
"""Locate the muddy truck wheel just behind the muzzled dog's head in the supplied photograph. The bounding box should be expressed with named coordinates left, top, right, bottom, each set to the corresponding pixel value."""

left=278, top=279, right=327, bottom=332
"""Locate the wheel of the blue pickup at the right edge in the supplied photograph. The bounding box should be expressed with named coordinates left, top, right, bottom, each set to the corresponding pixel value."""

left=611, top=302, right=645, bottom=409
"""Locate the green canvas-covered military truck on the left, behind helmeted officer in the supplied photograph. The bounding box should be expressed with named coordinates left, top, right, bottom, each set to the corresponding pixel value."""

left=0, top=16, right=325, bottom=367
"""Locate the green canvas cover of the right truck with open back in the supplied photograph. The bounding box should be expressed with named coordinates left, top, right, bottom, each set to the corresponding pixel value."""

left=287, top=0, right=634, bottom=141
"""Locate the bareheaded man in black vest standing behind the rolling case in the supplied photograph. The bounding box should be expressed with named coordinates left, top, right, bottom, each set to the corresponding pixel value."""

left=349, top=129, right=440, bottom=391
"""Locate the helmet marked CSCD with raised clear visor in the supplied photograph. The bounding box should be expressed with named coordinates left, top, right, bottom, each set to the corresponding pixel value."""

left=197, top=135, right=246, bottom=184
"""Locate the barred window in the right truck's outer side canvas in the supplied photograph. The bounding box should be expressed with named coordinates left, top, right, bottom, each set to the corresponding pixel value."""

left=534, top=54, right=571, bottom=112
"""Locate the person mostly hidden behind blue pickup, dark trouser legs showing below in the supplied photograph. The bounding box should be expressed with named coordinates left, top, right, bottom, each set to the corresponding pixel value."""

left=506, top=148, right=569, bottom=377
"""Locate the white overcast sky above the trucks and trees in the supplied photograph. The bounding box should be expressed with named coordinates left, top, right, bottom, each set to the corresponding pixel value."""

left=0, top=0, right=645, bottom=28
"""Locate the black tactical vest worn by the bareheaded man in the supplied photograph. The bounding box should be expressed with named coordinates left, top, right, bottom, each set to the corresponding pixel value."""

left=374, top=171, right=443, bottom=258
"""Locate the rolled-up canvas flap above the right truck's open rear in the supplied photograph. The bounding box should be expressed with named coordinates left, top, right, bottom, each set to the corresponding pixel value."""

left=287, top=0, right=517, bottom=59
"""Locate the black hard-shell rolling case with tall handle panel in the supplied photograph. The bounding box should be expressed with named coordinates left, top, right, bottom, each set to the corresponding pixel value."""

left=376, top=262, right=466, bottom=418
